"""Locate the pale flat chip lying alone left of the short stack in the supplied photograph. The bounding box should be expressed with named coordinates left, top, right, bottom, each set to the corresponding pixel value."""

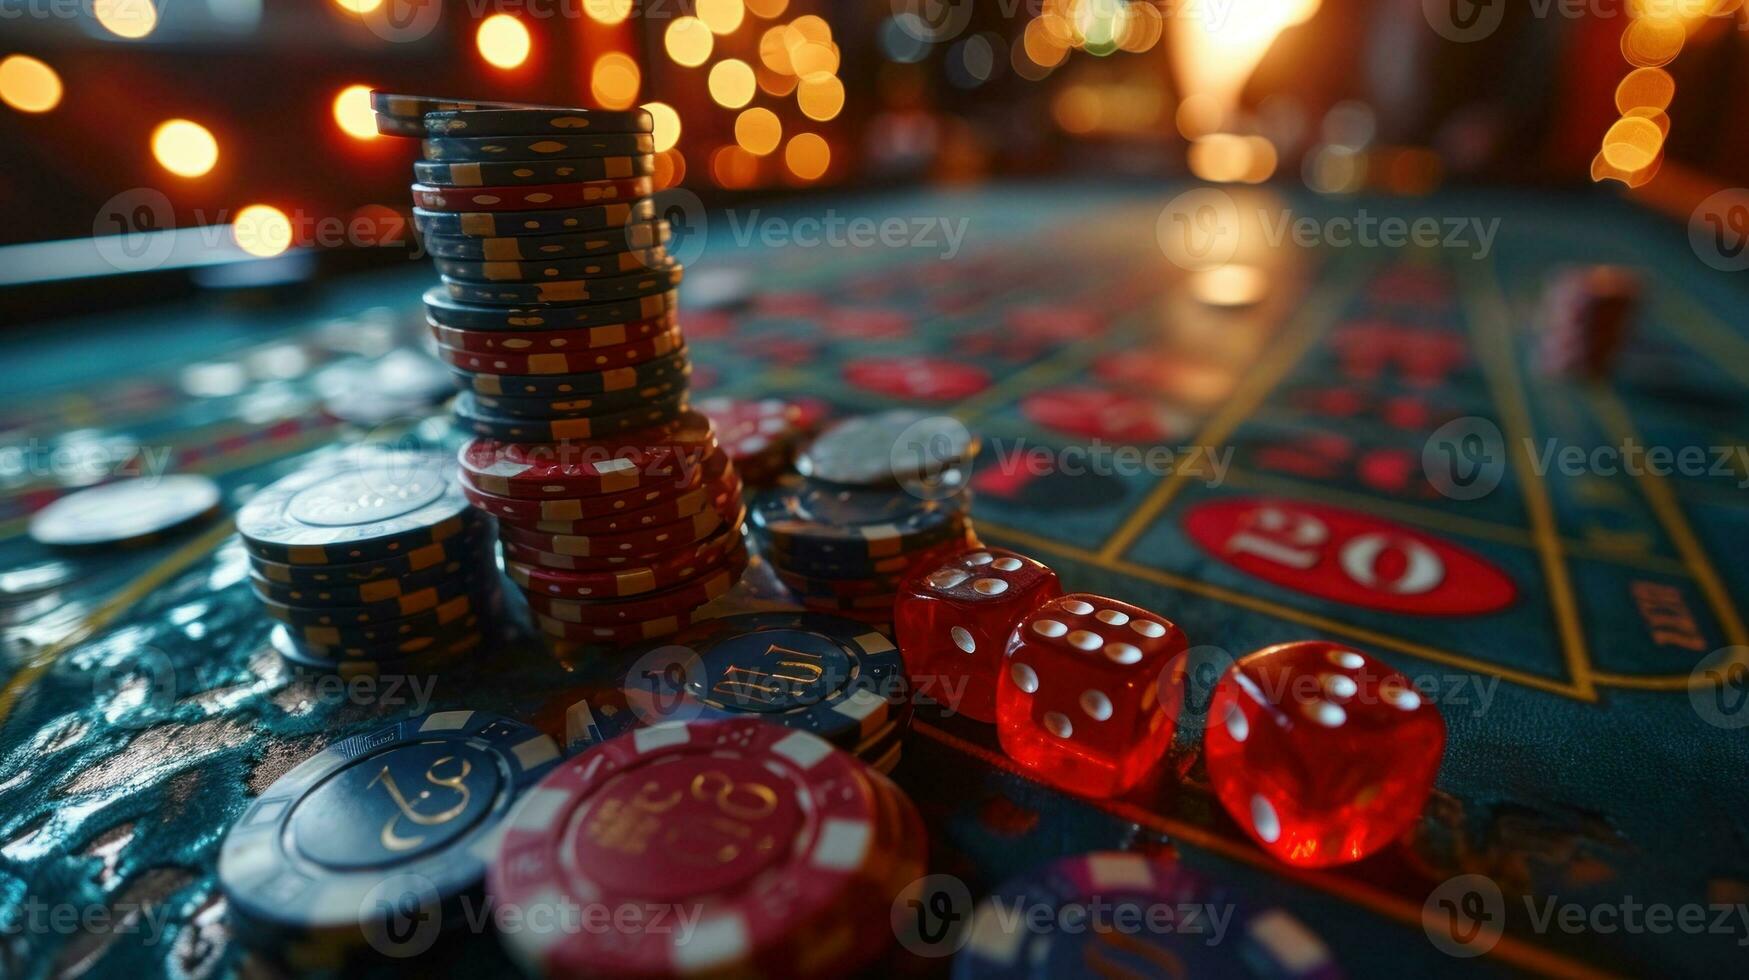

left=30, top=476, right=220, bottom=548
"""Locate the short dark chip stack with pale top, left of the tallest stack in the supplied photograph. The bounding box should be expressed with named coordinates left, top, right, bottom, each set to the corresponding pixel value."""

left=236, top=452, right=500, bottom=676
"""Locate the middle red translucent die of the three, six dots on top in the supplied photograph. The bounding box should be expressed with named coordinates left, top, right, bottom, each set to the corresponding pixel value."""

left=995, top=593, right=1188, bottom=796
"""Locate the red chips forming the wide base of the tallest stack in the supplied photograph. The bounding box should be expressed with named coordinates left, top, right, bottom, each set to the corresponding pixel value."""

left=460, top=410, right=747, bottom=644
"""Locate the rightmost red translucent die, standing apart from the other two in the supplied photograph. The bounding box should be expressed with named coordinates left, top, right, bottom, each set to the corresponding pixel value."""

left=1203, top=641, right=1445, bottom=868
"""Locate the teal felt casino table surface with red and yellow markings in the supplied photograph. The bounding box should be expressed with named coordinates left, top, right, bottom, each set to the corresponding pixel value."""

left=0, top=180, right=1749, bottom=978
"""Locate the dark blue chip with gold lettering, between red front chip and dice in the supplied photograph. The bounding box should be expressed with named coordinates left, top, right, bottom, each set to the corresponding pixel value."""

left=650, top=613, right=909, bottom=747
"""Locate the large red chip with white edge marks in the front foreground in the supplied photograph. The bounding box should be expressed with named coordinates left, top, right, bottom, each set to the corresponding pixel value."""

left=488, top=718, right=892, bottom=977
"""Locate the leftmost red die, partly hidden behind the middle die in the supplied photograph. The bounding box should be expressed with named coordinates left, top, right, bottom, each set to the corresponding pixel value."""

left=892, top=548, right=1063, bottom=721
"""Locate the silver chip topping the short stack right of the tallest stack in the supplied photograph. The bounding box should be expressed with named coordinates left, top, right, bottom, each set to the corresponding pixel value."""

left=796, top=410, right=978, bottom=492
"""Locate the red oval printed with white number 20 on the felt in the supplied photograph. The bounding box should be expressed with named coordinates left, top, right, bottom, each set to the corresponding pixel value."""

left=1179, top=497, right=1518, bottom=616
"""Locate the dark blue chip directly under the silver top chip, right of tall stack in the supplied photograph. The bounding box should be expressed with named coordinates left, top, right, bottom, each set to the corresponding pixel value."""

left=749, top=480, right=969, bottom=564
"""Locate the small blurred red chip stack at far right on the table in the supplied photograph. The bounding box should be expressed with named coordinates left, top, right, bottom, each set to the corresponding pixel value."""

left=1537, top=266, right=1641, bottom=378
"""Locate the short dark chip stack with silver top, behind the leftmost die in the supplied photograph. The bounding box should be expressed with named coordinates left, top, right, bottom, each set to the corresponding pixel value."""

left=749, top=410, right=978, bottom=623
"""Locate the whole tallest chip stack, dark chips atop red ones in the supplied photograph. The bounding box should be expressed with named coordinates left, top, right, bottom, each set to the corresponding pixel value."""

left=373, top=93, right=747, bottom=644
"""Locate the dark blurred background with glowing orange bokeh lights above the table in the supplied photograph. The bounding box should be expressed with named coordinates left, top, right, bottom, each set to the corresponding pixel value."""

left=0, top=0, right=1749, bottom=254
